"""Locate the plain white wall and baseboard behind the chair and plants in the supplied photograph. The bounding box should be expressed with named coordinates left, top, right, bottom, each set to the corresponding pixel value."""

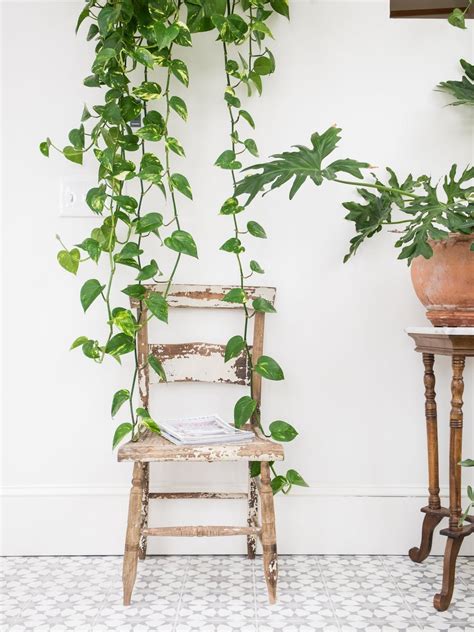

left=2, top=0, right=474, bottom=555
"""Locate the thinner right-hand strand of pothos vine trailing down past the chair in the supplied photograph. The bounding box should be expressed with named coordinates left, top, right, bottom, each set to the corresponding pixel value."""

left=212, top=0, right=306, bottom=493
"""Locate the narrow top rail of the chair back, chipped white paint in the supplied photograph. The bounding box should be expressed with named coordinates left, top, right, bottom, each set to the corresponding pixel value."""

left=132, top=283, right=276, bottom=309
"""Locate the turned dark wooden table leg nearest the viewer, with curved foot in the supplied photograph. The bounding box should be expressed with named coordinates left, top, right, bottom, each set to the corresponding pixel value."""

left=433, top=355, right=465, bottom=611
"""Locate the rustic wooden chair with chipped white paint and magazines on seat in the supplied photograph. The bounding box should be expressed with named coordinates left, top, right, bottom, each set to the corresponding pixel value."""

left=118, top=284, right=284, bottom=605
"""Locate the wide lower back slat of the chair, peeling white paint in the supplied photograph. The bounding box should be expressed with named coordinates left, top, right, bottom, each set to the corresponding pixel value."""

left=148, top=342, right=250, bottom=385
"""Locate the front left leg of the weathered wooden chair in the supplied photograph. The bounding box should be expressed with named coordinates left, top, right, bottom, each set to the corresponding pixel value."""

left=122, top=461, right=144, bottom=606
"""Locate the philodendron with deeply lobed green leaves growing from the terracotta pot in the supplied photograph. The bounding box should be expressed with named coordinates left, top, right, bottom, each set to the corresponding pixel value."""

left=236, top=124, right=474, bottom=523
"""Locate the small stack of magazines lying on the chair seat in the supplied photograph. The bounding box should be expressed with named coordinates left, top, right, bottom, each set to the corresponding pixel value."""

left=159, top=415, right=255, bottom=445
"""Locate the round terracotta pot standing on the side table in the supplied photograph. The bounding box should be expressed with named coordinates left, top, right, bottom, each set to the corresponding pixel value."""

left=411, top=233, right=474, bottom=327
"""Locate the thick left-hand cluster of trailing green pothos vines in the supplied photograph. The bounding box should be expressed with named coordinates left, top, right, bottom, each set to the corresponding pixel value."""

left=40, top=0, right=197, bottom=447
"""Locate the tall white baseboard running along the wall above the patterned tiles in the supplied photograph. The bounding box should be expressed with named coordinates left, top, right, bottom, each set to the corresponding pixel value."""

left=0, top=485, right=474, bottom=555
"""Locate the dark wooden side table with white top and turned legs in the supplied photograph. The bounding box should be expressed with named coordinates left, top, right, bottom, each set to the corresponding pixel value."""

left=406, top=327, right=474, bottom=611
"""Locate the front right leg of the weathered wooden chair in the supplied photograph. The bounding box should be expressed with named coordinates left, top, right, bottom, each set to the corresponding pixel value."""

left=260, top=462, right=278, bottom=604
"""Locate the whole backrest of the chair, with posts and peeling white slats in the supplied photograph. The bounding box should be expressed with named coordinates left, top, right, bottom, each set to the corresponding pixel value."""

left=131, top=283, right=276, bottom=408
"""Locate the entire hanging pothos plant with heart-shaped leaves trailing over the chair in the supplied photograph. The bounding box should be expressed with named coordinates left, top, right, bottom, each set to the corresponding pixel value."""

left=40, top=0, right=306, bottom=493
